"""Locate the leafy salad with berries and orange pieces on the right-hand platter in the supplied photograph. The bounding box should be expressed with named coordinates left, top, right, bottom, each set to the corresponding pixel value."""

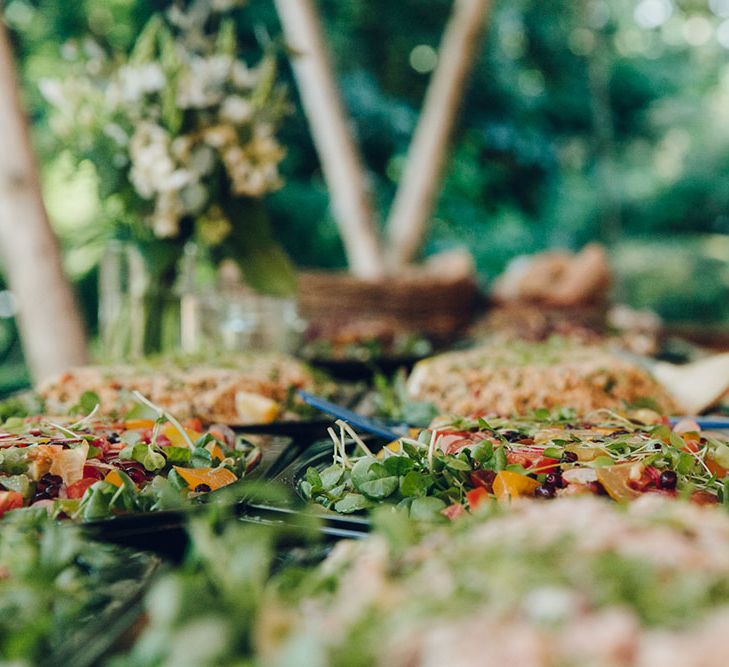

left=298, top=409, right=729, bottom=520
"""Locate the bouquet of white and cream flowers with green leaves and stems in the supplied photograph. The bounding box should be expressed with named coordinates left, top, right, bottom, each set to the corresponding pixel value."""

left=42, top=0, right=295, bottom=353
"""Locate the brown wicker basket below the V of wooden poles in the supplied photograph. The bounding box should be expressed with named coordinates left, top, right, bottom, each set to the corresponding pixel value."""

left=299, top=271, right=477, bottom=341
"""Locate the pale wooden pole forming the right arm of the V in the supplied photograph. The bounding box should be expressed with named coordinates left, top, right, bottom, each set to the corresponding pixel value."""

left=387, top=0, right=491, bottom=271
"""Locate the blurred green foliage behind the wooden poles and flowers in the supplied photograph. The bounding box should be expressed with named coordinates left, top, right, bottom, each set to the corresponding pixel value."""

left=0, top=0, right=729, bottom=394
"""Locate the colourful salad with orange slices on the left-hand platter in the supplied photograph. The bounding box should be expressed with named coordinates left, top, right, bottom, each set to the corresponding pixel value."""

left=0, top=395, right=261, bottom=521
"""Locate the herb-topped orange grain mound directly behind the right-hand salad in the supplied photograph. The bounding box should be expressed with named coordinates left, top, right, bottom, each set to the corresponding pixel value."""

left=408, top=338, right=675, bottom=416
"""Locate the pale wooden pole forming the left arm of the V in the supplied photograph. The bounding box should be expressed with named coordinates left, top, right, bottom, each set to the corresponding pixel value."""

left=276, top=0, right=385, bottom=279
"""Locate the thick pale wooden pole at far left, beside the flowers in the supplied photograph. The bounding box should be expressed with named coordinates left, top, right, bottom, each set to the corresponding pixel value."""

left=0, top=20, right=87, bottom=382
